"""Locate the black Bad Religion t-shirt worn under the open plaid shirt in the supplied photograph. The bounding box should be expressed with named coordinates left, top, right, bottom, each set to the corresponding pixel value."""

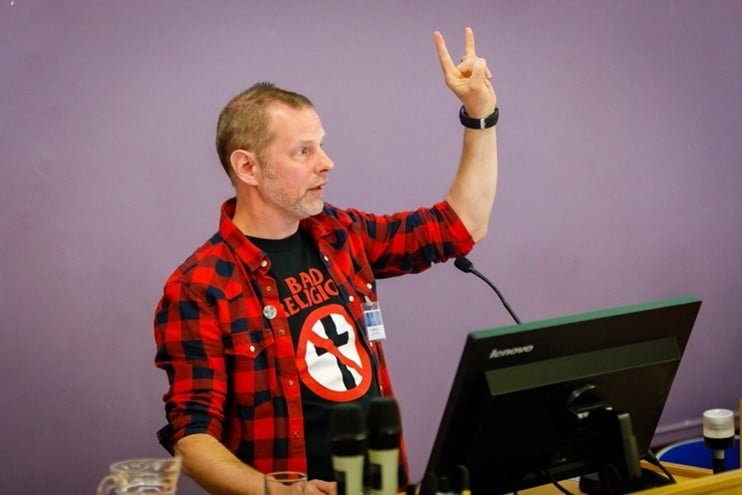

left=249, top=231, right=379, bottom=480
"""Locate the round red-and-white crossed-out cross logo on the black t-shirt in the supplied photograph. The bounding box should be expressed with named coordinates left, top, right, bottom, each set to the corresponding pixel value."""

left=297, top=304, right=372, bottom=402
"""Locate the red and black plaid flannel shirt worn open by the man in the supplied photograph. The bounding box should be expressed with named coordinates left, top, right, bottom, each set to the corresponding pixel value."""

left=155, top=199, right=473, bottom=480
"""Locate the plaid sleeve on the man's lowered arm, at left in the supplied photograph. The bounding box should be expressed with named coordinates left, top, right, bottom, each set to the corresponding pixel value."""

left=155, top=281, right=227, bottom=453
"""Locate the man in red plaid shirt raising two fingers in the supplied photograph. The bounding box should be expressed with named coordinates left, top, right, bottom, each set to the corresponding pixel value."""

left=155, top=28, right=497, bottom=495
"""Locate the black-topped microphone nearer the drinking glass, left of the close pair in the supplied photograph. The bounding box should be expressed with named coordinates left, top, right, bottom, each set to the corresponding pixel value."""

left=330, top=404, right=367, bottom=495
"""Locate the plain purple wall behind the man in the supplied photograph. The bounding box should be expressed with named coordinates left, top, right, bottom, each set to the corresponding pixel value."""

left=0, top=0, right=742, bottom=494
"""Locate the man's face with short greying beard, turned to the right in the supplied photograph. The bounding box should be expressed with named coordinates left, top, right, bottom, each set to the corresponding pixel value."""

left=258, top=104, right=334, bottom=220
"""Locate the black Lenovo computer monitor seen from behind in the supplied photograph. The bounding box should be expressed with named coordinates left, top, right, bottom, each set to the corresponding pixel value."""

left=426, top=297, right=701, bottom=495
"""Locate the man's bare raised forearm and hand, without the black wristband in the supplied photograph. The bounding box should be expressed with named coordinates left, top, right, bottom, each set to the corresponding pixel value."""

left=433, top=27, right=497, bottom=242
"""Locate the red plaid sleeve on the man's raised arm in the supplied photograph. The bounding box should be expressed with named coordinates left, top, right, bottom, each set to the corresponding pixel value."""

left=351, top=201, right=474, bottom=278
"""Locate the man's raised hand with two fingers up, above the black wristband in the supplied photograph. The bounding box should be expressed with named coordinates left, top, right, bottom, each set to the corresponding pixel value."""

left=433, top=27, right=497, bottom=118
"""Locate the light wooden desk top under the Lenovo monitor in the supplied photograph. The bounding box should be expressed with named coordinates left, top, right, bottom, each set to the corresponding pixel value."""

left=519, top=463, right=742, bottom=495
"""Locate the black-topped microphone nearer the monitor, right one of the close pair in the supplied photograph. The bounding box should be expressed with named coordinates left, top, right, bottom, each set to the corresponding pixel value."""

left=366, top=397, right=402, bottom=495
